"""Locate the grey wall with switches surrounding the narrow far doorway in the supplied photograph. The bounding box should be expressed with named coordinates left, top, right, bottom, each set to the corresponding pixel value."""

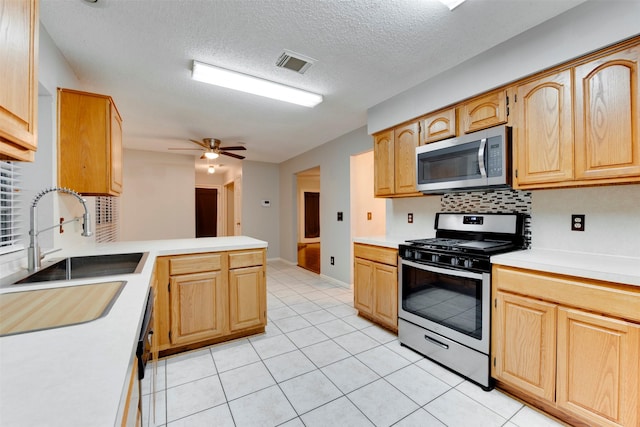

left=280, top=127, right=372, bottom=284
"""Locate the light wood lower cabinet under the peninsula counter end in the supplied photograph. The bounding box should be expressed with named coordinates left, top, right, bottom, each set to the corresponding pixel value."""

left=156, top=249, right=267, bottom=352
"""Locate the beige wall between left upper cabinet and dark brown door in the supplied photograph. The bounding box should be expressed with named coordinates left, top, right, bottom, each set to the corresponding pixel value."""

left=120, top=149, right=196, bottom=241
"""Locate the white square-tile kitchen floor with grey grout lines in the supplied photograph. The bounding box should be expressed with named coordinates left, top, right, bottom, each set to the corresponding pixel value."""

left=142, top=261, right=560, bottom=427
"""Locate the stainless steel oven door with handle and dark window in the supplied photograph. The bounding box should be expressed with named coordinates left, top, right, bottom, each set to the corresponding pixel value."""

left=398, top=260, right=491, bottom=354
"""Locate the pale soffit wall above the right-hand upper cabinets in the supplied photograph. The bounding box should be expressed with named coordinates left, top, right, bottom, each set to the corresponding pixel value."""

left=367, top=0, right=640, bottom=133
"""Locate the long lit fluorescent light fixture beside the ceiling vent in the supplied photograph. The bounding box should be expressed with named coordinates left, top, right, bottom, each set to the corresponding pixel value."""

left=191, top=61, right=322, bottom=107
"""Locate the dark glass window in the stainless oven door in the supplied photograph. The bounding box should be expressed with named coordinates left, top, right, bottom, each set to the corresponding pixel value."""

left=402, top=265, right=482, bottom=339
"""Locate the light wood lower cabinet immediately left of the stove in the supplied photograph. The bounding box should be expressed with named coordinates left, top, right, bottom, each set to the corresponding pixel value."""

left=353, top=243, right=398, bottom=332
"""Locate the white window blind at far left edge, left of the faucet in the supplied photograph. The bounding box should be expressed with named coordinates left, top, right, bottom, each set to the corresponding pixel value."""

left=0, top=161, right=24, bottom=254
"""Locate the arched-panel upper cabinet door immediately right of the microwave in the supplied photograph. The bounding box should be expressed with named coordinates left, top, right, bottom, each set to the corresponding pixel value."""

left=513, top=70, right=573, bottom=187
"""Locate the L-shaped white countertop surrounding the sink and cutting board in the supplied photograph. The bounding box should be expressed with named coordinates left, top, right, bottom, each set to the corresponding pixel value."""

left=0, top=236, right=267, bottom=427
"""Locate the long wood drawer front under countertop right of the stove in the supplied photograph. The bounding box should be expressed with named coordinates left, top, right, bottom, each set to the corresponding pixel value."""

left=492, top=266, right=640, bottom=322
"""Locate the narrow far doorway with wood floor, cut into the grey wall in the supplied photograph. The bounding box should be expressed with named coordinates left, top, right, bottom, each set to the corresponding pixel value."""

left=296, top=166, right=321, bottom=274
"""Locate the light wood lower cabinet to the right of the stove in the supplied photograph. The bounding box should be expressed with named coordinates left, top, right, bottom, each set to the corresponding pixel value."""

left=492, top=266, right=640, bottom=427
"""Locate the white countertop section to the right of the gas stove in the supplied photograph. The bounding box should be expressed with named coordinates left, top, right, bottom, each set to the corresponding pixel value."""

left=491, top=249, right=640, bottom=286
